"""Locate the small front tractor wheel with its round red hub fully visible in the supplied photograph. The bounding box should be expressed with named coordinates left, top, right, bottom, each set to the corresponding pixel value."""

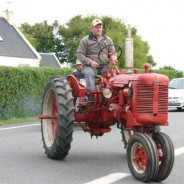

left=127, top=133, right=158, bottom=182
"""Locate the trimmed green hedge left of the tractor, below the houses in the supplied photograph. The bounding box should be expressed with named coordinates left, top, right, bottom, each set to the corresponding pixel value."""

left=0, top=67, right=73, bottom=120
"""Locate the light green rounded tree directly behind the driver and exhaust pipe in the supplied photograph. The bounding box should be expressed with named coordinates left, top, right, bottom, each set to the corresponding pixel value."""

left=59, top=15, right=155, bottom=68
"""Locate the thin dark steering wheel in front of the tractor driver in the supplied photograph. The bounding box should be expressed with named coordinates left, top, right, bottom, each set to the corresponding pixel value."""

left=98, top=44, right=122, bottom=64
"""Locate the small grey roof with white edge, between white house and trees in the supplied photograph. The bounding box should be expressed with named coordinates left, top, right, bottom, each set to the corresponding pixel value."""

left=39, top=53, right=61, bottom=68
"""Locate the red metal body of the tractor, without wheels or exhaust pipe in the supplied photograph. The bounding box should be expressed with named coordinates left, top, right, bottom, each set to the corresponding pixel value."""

left=67, top=66, right=169, bottom=134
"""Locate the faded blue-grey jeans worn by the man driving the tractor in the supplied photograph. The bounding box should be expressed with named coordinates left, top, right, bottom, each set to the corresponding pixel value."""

left=83, top=65, right=106, bottom=93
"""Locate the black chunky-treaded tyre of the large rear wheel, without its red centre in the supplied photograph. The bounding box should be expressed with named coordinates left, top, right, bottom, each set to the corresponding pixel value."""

left=42, top=77, right=74, bottom=159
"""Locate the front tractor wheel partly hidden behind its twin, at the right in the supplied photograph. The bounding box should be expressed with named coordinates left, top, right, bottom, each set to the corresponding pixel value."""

left=153, top=132, right=174, bottom=181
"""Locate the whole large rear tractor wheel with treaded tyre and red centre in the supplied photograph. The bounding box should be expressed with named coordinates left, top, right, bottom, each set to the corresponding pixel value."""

left=41, top=77, right=74, bottom=159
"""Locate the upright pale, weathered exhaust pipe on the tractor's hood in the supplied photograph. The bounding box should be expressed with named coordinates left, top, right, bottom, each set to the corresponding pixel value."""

left=125, top=24, right=134, bottom=73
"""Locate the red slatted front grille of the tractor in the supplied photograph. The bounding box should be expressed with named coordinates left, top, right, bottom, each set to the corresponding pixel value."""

left=136, top=84, right=168, bottom=114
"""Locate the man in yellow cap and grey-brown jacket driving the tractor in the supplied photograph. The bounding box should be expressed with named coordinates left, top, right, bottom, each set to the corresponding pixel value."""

left=77, top=19, right=116, bottom=95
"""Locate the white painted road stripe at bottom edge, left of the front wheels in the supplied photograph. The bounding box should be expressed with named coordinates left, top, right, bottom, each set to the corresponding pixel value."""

left=85, top=173, right=130, bottom=184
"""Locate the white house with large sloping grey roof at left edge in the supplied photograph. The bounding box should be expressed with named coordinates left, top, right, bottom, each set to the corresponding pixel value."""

left=0, top=17, right=41, bottom=67
